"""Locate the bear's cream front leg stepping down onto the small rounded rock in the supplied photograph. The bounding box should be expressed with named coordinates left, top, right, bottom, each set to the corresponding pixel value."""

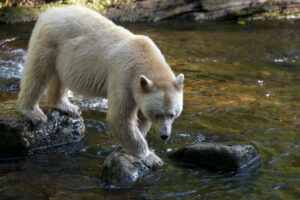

left=107, top=106, right=163, bottom=169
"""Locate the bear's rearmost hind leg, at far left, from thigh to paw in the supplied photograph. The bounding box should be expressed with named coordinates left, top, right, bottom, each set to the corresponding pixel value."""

left=17, top=44, right=54, bottom=124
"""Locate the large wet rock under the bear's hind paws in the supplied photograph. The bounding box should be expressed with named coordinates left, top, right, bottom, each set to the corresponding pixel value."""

left=0, top=101, right=85, bottom=157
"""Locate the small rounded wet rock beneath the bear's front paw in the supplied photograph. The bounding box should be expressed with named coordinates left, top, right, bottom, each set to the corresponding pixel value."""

left=101, top=152, right=151, bottom=188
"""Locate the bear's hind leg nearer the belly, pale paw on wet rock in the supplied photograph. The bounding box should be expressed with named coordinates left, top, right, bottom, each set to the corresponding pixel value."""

left=46, top=75, right=80, bottom=117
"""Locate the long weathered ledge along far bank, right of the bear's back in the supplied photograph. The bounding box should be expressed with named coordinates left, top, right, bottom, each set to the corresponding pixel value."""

left=102, top=0, right=300, bottom=21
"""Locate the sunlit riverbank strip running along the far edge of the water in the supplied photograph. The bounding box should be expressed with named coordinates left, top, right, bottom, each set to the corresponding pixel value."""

left=0, top=0, right=300, bottom=23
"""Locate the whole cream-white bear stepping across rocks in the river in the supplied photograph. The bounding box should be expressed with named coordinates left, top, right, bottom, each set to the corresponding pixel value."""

left=17, top=6, right=184, bottom=168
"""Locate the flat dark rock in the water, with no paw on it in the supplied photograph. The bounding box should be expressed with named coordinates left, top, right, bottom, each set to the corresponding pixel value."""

left=168, top=143, right=259, bottom=172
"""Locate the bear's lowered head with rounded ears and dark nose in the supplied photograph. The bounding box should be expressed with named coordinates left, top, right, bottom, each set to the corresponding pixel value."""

left=138, top=74, right=184, bottom=140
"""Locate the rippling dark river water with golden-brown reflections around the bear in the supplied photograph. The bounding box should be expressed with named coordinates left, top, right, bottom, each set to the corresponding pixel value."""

left=0, top=21, right=300, bottom=200
